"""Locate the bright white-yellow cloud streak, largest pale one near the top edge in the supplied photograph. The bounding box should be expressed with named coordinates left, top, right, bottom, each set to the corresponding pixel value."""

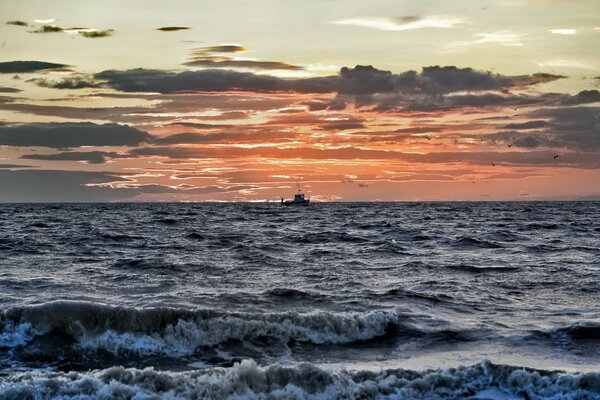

left=331, top=15, right=464, bottom=31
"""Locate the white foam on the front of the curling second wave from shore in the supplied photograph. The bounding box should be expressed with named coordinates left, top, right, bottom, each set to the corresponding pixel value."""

left=77, top=311, right=399, bottom=356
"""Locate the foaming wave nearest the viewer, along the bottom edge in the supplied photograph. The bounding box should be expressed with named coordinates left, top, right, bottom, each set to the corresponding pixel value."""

left=0, top=360, right=600, bottom=400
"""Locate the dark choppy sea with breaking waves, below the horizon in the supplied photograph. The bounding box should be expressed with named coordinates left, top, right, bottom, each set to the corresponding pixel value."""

left=0, top=202, right=600, bottom=399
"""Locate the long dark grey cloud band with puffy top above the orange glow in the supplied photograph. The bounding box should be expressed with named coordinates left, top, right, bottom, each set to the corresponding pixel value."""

left=82, top=65, right=564, bottom=95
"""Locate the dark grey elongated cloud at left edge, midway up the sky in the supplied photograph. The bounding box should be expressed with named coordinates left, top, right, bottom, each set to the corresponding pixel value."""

left=0, top=122, right=152, bottom=148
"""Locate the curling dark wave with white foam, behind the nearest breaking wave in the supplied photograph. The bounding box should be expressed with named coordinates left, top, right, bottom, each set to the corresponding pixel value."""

left=0, top=301, right=413, bottom=356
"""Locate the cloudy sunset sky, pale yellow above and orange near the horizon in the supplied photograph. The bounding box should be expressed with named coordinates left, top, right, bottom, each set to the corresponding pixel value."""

left=0, top=0, right=600, bottom=202
